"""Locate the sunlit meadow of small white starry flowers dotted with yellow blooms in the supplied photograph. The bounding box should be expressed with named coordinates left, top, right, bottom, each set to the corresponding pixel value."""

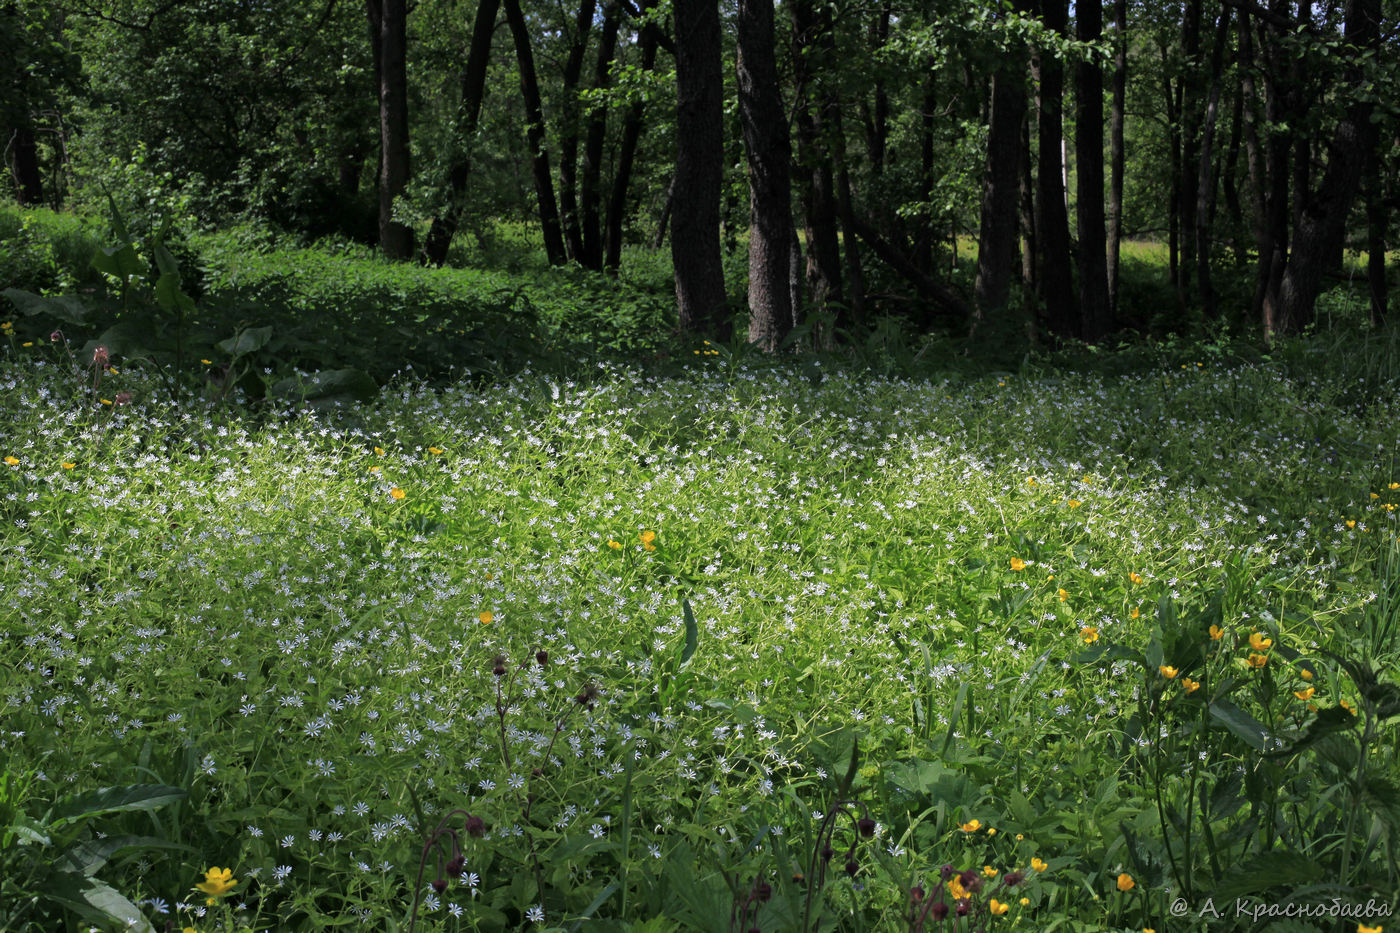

left=0, top=210, right=1400, bottom=933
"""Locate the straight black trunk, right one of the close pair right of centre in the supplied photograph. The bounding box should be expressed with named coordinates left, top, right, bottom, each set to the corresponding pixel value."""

left=1074, top=0, right=1110, bottom=342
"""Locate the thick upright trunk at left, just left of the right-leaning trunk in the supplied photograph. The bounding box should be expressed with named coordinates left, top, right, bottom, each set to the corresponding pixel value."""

left=367, top=0, right=413, bottom=261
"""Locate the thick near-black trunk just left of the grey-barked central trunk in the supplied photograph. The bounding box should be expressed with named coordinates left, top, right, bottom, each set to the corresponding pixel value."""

left=671, top=0, right=729, bottom=339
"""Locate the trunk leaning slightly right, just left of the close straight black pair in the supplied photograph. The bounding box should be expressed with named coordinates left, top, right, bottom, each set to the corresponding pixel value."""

left=972, top=17, right=1026, bottom=332
